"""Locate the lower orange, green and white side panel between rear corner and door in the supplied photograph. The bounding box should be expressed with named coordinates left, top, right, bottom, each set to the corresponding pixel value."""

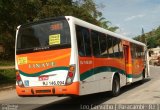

left=79, top=57, right=126, bottom=95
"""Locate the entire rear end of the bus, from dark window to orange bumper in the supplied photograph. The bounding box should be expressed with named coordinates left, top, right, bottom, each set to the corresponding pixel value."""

left=16, top=19, right=78, bottom=96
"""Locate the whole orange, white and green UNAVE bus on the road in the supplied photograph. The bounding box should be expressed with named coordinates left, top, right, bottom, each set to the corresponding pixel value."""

left=15, top=16, right=149, bottom=96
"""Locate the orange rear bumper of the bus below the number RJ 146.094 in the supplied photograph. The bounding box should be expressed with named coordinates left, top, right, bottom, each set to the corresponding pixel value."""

left=16, top=82, right=79, bottom=96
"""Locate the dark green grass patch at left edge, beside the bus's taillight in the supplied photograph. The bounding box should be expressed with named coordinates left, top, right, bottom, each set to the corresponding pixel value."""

left=0, top=69, right=16, bottom=85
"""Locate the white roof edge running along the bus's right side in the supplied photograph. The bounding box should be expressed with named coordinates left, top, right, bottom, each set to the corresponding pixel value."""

left=65, top=16, right=146, bottom=46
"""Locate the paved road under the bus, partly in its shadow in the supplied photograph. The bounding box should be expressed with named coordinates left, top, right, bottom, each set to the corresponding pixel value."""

left=0, top=67, right=160, bottom=110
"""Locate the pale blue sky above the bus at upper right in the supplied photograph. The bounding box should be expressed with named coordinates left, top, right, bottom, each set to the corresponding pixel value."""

left=94, top=0, right=160, bottom=38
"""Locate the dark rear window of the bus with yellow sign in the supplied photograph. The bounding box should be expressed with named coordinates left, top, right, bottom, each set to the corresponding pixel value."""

left=17, top=20, right=71, bottom=51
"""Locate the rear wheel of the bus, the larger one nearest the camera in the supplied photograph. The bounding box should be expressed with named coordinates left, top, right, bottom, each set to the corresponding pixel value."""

left=111, top=75, right=120, bottom=97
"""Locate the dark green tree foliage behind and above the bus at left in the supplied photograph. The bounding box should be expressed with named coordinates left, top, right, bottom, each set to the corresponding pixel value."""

left=0, top=0, right=118, bottom=59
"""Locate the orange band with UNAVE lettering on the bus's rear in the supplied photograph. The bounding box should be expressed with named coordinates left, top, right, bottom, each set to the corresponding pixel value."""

left=16, top=48, right=71, bottom=74
